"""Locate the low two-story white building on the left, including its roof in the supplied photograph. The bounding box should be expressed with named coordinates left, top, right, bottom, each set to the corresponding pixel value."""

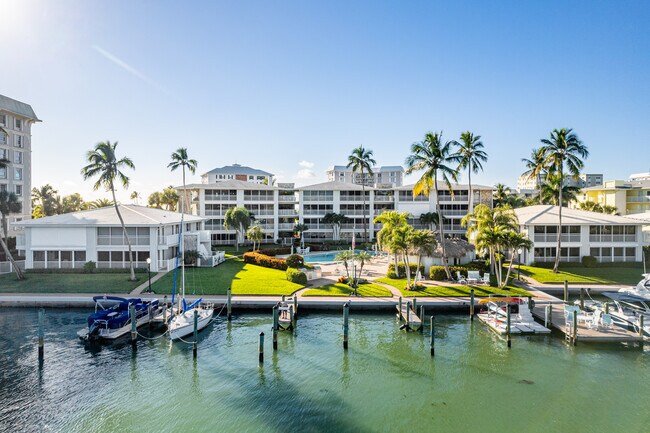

left=14, top=205, right=222, bottom=272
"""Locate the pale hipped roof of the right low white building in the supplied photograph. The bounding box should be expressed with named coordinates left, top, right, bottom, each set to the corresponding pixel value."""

left=515, top=205, right=641, bottom=225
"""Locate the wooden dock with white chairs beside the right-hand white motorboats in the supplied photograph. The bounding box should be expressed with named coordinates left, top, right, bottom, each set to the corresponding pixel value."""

left=533, top=302, right=643, bottom=343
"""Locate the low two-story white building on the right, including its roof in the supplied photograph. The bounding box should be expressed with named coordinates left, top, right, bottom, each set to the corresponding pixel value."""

left=515, top=205, right=643, bottom=264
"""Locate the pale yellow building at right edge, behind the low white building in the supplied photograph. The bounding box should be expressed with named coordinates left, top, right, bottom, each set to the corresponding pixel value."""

left=577, top=179, right=650, bottom=215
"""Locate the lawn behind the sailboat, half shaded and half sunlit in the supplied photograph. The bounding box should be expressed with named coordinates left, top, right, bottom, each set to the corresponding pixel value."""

left=152, top=259, right=303, bottom=295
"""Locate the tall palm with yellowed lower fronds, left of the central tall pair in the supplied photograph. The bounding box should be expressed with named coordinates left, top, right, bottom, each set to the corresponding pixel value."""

left=406, top=132, right=460, bottom=279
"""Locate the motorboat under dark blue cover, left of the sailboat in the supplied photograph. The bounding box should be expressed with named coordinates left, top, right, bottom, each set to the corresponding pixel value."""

left=77, top=296, right=161, bottom=340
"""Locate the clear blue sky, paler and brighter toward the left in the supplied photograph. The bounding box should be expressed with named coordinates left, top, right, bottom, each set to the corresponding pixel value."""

left=0, top=0, right=650, bottom=202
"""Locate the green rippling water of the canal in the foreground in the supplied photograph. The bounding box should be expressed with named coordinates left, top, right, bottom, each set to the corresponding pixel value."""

left=0, top=309, right=650, bottom=433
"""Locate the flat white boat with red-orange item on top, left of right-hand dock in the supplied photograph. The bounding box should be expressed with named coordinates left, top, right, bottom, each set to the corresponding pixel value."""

left=477, top=296, right=551, bottom=334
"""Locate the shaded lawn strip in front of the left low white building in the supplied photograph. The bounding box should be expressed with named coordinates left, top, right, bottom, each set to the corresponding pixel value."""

left=0, top=271, right=142, bottom=294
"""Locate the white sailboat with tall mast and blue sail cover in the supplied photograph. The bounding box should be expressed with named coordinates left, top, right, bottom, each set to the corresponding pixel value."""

left=167, top=197, right=214, bottom=341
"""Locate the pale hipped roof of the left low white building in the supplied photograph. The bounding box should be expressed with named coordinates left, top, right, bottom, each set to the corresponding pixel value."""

left=14, top=204, right=207, bottom=227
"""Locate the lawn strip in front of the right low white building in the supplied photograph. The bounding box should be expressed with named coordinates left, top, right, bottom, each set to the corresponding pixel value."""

left=513, top=264, right=643, bottom=285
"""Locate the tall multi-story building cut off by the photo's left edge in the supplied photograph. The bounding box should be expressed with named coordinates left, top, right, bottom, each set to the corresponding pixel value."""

left=0, top=95, right=40, bottom=228
